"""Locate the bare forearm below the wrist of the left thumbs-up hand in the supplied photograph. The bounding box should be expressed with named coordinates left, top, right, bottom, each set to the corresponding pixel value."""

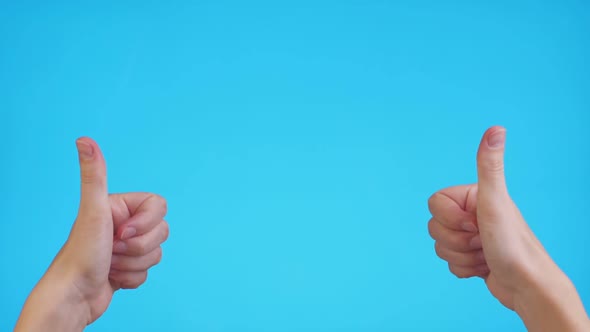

left=14, top=274, right=88, bottom=332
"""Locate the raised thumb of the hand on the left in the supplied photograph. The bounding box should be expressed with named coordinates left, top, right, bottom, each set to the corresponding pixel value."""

left=76, top=137, right=108, bottom=213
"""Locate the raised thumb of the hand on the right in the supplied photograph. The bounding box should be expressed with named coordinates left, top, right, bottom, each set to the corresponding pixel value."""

left=477, top=126, right=508, bottom=203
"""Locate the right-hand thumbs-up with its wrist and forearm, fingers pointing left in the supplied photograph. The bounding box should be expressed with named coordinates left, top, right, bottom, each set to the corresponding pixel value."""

left=428, top=127, right=590, bottom=332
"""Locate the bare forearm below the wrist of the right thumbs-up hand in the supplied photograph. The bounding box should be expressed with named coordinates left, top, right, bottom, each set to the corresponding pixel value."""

left=515, top=264, right=590, bottom=332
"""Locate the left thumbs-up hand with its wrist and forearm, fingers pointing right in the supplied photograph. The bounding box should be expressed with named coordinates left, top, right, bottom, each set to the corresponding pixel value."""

left=15, top=138, right=168, bottom=332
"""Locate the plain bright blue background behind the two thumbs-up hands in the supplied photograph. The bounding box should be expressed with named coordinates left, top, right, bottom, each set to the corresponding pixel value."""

left=0, top=1, right=590, bottom=331
